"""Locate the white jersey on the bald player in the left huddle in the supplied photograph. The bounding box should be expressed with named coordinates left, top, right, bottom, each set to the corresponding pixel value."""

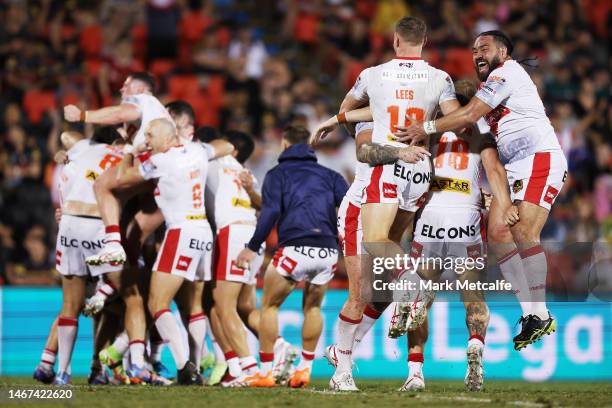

left=147, top=143, right=208, bottom=226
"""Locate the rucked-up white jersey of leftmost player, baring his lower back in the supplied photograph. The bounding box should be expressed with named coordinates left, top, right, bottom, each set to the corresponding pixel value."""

left=60, top=140, right=123, bottom=204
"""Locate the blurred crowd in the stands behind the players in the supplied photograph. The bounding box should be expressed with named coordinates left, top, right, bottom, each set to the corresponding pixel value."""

left=0, top=0, right=612, bottom=284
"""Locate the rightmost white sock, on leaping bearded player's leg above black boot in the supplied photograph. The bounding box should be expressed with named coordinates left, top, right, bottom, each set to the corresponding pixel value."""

left=521, top=245, right=548, bottom=320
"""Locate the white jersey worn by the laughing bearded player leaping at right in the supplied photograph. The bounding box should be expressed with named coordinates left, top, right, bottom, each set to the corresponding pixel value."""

left=476, top=60, right=561, bottom=164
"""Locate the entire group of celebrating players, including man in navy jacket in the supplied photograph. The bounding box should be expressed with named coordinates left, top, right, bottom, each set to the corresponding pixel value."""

left=29, top=17, right=567, bottom=391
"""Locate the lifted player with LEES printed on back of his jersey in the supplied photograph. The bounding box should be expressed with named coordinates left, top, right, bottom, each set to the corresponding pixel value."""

left=310, top=17, right=458, bottom=390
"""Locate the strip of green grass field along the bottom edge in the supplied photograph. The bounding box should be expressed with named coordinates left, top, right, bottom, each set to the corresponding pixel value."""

left=0, top=377, right=612, bottom=408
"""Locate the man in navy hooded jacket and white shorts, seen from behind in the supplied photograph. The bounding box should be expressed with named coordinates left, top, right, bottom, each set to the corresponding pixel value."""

left=237, top=127, right=348, bottom=387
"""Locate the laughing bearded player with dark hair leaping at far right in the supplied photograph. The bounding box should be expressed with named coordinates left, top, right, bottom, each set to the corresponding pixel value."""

left=400, top=30, right=567, bottom=350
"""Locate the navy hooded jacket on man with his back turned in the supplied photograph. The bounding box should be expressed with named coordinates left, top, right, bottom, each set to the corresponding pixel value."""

left=248, top=143, right=348, bottom=252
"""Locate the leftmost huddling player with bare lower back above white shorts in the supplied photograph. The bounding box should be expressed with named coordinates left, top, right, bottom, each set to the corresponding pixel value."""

left=54, top=129, right=126, bottom=385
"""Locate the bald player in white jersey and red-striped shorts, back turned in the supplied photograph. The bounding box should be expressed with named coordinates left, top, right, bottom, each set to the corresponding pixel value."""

left=109, top=119, right=214, bottom=384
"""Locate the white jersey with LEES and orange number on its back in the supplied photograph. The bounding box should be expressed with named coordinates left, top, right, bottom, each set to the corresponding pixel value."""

left=356, top=57, right=455, bottom=146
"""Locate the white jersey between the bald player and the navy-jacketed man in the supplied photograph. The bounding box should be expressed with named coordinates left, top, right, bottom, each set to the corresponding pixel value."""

left=206, top=155, right=257, bottom=229
